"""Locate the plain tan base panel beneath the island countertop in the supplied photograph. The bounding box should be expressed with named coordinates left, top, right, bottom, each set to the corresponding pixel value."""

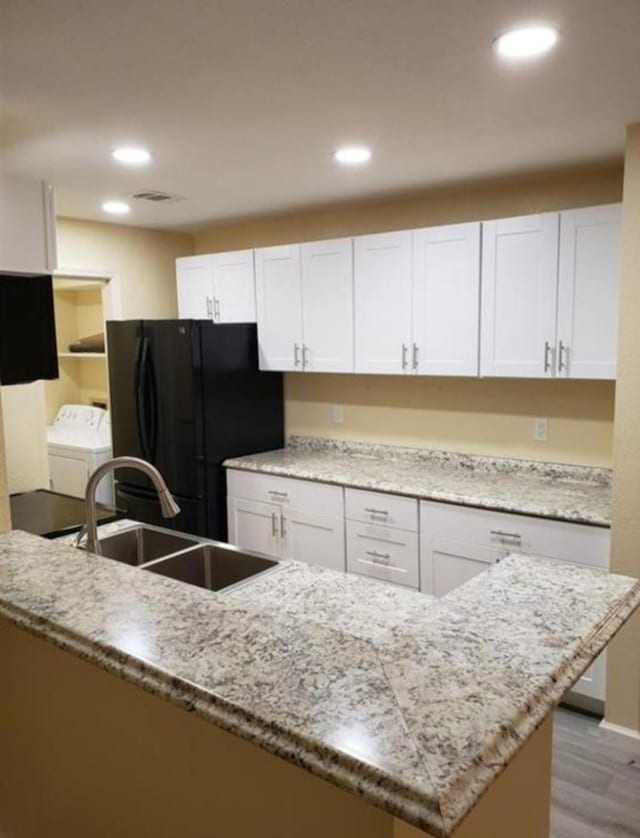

left=0, top=619, right=550, bottom=838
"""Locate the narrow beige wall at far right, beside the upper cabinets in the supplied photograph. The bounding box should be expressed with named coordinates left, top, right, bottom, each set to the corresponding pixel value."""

left=607, top=123, right=640, bottom=731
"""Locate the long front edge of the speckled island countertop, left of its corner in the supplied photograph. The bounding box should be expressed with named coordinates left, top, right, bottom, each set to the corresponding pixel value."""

left=0, top=600, right=451, bottom=838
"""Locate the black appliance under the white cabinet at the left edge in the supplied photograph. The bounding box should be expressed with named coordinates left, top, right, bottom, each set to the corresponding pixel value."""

left=0, top=274, right=58, bottom=385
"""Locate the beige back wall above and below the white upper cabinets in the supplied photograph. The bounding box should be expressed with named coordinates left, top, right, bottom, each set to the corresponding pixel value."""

left=196, top=165, right=622, bottom=465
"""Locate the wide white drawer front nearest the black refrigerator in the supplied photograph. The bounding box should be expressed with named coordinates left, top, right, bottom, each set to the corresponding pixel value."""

left=227, top=469, right=344, bottom=518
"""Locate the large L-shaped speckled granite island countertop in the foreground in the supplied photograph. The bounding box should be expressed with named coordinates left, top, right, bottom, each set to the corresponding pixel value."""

left=0, top=532, right=640, bottom=836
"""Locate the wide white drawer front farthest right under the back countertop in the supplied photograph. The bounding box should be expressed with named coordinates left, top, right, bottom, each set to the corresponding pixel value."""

left=420, top=501, right=610, bottom=569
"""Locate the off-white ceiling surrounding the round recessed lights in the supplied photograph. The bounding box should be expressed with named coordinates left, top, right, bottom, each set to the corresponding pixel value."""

left=0, top=0, right=640, bottom=229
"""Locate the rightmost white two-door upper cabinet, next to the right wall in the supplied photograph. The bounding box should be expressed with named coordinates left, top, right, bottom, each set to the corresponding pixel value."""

left=480, top=204, right=621, bottom=378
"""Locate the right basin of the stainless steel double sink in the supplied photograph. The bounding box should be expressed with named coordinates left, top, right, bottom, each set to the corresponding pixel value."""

left=142, top=542, right=280, bottom=591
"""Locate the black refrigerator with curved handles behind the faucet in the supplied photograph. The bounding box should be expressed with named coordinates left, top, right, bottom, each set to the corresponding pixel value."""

left=107, top=320, right=284, bottom=541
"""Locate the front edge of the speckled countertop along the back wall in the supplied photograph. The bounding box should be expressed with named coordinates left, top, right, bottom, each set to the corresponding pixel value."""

left=223, top=457, right=611, bottom=529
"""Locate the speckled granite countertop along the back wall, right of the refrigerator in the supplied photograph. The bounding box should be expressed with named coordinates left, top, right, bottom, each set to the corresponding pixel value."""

left=224, top=436, right=611, bottom=527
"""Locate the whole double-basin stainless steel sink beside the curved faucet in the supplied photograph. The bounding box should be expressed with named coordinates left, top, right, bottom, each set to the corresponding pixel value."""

left=92, top=524, right=281, bottom=591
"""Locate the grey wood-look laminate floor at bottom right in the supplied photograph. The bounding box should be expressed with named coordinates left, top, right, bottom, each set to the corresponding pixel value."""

left=551, top=709, right=640, bottom=838
